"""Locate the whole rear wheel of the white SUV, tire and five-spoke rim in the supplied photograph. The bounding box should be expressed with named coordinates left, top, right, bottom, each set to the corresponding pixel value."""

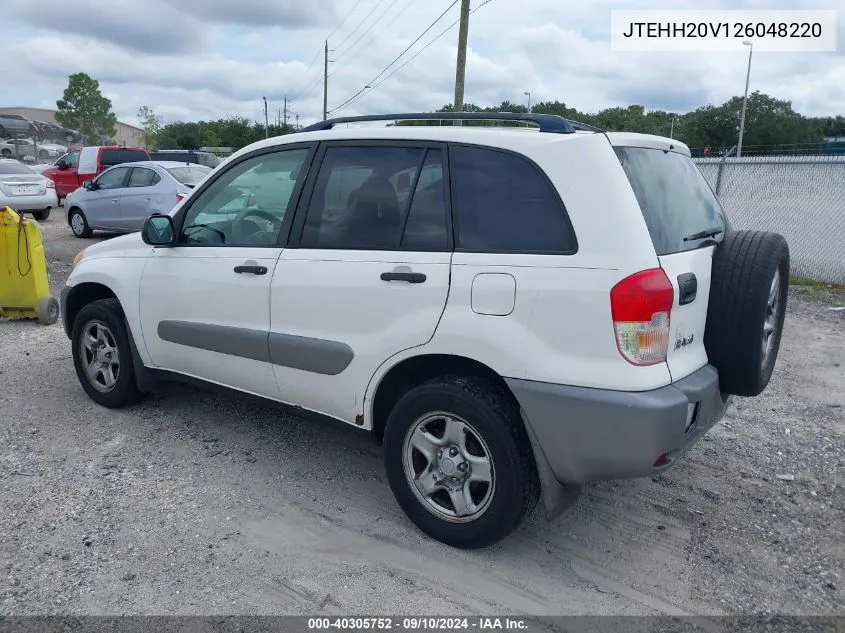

left=384, top=376, right=540, bottom=549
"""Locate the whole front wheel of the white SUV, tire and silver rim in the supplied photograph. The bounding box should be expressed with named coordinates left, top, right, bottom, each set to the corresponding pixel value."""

left=71, top=299, right=144, bottom=408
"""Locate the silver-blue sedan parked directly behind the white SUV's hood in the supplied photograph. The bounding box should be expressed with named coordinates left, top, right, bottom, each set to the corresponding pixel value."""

left=65, top=161, right=212, bottom=237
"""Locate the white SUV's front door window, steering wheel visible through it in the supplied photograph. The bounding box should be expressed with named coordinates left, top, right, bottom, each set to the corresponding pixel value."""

left=179, top=149, right=310, bottom=246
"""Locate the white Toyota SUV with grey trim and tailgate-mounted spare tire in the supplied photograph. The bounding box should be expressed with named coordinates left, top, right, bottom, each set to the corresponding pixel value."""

left=62, top=113, right=789, bottom=548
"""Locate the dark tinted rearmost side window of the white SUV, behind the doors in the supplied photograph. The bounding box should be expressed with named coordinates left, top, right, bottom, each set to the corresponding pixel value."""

left=452, top=146, right=577, bottom=254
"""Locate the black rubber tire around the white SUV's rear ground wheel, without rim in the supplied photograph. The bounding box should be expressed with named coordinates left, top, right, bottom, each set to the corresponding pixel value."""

left=384, top=376, right=540, bottom=549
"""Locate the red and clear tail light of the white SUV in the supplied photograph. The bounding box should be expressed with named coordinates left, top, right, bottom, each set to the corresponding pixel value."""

left=610, top=268, right=675, bottom=365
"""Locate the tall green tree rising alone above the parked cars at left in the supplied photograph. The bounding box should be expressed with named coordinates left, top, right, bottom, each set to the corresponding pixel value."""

left=56, top=73, right=117, bottom=143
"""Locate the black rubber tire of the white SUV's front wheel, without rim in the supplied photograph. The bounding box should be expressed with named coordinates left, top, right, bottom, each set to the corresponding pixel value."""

left=71, top=299, right=146, bottom=409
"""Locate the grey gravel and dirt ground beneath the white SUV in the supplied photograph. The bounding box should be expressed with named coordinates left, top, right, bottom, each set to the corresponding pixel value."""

left=0, top=213, right=845, bottom=615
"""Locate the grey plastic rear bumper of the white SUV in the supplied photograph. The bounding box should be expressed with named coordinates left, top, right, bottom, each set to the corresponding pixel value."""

left=507, top=365, right=731, bottom=484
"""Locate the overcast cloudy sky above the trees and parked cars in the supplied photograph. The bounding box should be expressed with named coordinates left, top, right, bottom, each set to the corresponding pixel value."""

left=0, top=0, right=845, bottom=123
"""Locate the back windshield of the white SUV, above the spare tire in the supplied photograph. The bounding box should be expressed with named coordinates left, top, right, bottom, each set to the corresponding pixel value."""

left=615, top=147, right=728, bottom=255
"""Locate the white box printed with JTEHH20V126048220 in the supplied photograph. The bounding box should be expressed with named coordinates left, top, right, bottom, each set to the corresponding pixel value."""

left=610, top=10, right=836, bottom=53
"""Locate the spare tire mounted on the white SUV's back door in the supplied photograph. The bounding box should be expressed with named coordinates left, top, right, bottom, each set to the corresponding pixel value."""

left=704, top=231, right=789, bottom=397
